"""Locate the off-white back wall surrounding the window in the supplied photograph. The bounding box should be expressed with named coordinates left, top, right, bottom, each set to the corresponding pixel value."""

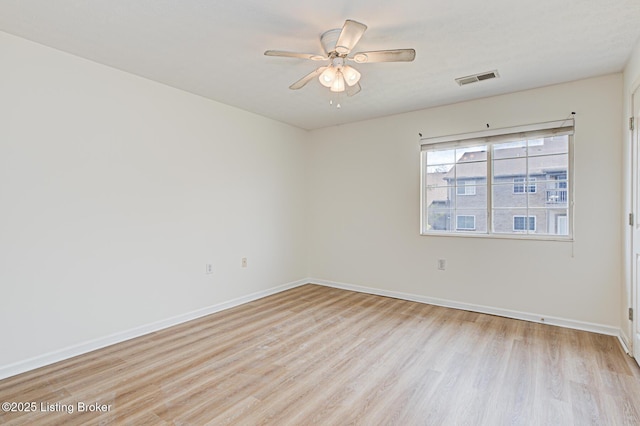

left=309, top=74, right=623, bottom=329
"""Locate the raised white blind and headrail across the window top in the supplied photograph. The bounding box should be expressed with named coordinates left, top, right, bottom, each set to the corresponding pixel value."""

left=420, top=118, right=574, bottom=151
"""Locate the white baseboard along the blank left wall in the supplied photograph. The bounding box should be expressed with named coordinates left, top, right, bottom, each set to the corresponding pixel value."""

left=0, top=279, right=309, bottom=380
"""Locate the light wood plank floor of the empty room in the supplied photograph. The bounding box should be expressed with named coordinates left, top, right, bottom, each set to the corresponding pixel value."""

left=0, top=285, right=640, bottom=426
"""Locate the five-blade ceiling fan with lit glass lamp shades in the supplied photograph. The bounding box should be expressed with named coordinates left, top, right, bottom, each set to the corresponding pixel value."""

left=264, top=19, right=416, bottom=96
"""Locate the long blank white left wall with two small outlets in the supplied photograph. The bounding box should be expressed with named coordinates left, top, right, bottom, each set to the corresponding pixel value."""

left=0, top=33, right=307, bottom=370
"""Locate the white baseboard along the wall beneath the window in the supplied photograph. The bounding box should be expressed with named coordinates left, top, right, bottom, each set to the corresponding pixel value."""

left=309, top=278, right=626, bottom=338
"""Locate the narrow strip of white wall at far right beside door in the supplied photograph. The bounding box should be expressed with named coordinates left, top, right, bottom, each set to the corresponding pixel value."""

left=620, top=39, right=640, bottom=348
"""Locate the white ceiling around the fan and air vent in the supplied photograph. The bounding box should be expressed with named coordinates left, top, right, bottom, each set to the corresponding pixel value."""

left=0, top=0, right=640, bottom=129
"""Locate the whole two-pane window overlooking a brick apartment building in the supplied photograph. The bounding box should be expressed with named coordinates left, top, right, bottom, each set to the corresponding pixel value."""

left=421, top=119, right=573, bottom=239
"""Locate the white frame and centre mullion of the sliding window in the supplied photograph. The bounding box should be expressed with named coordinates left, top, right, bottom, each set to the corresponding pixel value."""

left=420, top=118, right=575, bottom=242
